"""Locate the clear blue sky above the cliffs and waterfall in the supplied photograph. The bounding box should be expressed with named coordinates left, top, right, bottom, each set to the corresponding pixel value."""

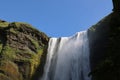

left=0, top=0, right=112, bottom=37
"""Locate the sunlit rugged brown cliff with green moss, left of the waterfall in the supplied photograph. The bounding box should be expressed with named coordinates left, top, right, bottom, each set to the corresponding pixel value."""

left=0, top=20, right=48, bottom=80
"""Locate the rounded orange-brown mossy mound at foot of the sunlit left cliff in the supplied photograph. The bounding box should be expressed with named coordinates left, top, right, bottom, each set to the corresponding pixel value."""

left=0, top=60, right=22, bottom=80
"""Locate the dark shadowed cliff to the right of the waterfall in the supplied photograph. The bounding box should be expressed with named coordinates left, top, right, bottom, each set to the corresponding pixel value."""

left=88, top=12, right=120, bottom=80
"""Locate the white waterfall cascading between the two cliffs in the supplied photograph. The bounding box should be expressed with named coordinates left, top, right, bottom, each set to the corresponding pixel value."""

left=40, top=31, right=91, bottom=80
